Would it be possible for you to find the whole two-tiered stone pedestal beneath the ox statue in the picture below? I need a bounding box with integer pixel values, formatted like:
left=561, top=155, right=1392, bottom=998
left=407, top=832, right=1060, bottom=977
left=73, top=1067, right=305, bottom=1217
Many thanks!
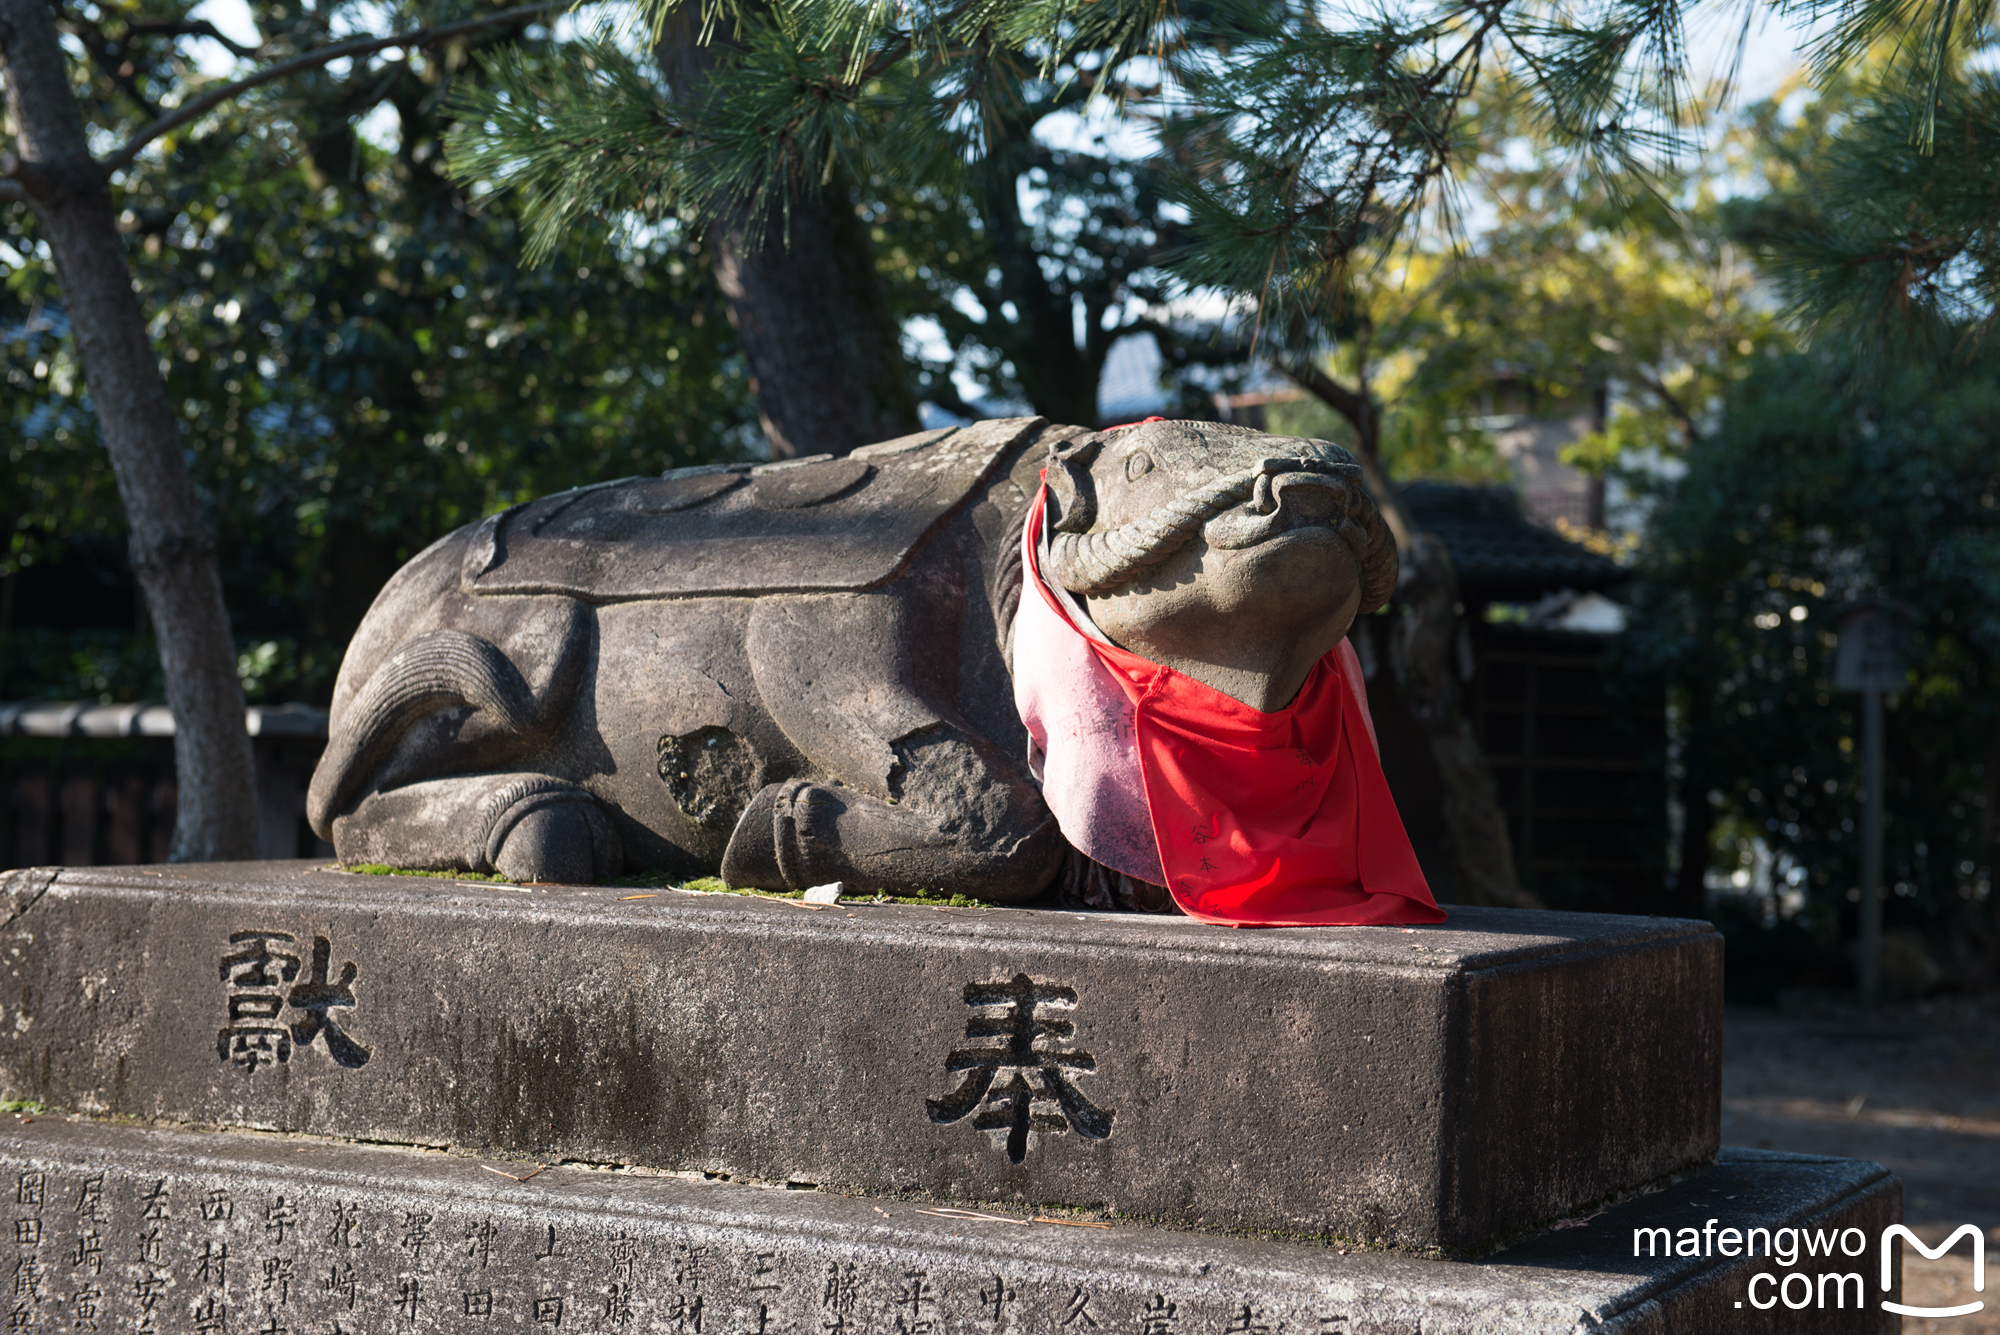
left=0, top=863, right=1902, bottom=1335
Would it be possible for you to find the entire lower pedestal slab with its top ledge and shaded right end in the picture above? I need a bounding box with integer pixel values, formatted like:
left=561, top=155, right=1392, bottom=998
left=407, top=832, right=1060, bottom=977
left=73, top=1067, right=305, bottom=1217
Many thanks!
left=0, top=1117, right=1900, bottom=1335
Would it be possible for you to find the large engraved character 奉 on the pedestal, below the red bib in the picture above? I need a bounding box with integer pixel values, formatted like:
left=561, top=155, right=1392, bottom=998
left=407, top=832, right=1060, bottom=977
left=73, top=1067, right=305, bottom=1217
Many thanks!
left=924, top=973, right=1116, bottom=1163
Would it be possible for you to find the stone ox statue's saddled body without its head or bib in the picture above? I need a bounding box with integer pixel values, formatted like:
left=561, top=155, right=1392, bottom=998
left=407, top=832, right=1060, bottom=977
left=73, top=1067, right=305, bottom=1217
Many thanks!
left=308, top=418, right=1080, bottom=901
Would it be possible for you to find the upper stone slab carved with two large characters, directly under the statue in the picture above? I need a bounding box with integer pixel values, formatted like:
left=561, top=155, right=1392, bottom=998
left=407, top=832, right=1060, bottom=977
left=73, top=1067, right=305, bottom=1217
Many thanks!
left=0, top=863, right=1722, bottom=1253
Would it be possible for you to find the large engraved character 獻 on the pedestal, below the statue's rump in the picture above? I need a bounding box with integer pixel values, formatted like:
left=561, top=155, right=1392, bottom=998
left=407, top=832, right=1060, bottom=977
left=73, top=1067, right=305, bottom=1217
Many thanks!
left=216, top=931, right=368, bottom=1071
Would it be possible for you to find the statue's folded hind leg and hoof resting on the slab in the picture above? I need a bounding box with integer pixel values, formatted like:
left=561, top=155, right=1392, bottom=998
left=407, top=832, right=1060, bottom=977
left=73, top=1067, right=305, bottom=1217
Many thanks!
left=334, top=773, right=624, bottom=881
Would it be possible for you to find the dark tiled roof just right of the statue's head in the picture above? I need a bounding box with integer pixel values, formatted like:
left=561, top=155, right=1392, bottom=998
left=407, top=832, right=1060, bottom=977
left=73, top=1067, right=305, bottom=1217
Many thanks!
left=1402, top=482, right=1630, bottom=602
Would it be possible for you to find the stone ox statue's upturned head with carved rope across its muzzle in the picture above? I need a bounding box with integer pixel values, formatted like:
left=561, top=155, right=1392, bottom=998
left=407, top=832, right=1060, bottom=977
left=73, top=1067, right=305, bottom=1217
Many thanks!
left=1042, top=422, right=1396, bottom=703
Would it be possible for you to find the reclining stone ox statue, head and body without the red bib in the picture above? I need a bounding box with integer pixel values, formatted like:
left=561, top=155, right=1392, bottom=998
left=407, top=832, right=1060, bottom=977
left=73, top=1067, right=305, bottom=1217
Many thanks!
left=306, top=418, right=1396, bottom=903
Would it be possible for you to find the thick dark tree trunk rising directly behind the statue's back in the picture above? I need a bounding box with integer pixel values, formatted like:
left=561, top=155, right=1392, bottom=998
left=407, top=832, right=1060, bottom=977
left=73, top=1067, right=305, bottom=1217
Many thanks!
left=658, top=6, right=918, bottom=458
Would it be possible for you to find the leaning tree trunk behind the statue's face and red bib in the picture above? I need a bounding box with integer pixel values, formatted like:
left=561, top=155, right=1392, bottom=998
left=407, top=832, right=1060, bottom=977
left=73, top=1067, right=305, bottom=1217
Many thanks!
left=1284, top=362, right=1542, bottom=907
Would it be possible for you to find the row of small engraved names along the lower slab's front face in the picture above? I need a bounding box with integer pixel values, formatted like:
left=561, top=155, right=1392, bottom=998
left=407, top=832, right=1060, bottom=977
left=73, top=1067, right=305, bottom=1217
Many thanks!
left=0, top=1159, right=1366, bottom=1335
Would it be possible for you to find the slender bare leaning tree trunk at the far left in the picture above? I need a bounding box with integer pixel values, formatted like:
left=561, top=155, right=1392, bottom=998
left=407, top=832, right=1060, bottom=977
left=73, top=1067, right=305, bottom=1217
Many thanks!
left=0, top=0, right=256, bottom=861
